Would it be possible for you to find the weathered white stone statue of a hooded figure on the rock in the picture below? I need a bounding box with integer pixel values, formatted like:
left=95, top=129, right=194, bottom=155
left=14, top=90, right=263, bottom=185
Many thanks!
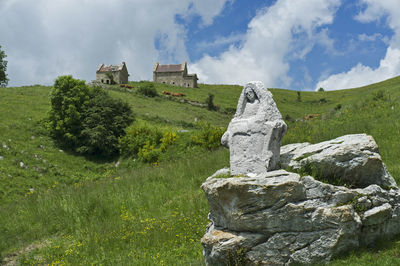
left=221, top=81, right=287, bottom=175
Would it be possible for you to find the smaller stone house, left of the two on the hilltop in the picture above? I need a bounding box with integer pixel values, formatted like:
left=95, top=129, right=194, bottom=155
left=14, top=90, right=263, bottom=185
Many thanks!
left=96, top=62, right=129, bottom=84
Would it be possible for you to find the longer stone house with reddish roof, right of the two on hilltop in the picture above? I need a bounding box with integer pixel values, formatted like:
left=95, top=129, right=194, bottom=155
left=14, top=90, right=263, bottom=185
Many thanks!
left=153, top=62, right=198, bottom=88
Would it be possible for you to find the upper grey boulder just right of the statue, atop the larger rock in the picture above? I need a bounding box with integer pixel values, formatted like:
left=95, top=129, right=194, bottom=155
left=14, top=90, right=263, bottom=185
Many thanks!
left=281, top=134, right=396, bottom=187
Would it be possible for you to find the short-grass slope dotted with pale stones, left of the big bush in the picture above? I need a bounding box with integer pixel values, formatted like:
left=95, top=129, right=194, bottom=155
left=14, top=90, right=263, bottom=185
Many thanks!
left=0, top=86, right=113, bottom=204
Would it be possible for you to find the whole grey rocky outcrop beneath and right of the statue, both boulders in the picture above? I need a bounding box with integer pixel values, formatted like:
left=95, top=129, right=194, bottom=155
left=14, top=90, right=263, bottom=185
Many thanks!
left=202, top=134, right=400, bottom=265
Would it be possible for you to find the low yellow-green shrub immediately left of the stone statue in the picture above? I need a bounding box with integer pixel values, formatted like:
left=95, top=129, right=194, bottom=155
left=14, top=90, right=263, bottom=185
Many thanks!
left=190, top=123, right=225, bottom=150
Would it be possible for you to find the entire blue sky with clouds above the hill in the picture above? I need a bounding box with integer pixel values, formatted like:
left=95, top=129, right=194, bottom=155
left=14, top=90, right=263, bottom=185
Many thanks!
left=0, top=0, right=400, bottom=90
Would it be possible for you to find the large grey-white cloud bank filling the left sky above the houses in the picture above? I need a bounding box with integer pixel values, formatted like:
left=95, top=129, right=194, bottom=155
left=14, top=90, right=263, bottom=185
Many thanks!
left=0, top=0, right=229, bottom=86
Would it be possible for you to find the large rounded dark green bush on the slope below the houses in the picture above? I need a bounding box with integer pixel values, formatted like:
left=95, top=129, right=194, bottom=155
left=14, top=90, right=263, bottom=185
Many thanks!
left=48, top=76, right=134, bottom=156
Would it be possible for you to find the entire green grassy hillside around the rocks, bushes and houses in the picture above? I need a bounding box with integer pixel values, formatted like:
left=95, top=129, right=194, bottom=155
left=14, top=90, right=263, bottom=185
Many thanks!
left=0, top=77, right=400, bottom=265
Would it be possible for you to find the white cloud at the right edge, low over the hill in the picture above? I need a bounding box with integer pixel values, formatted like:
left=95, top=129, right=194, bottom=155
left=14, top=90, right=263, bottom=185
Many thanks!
left=315, top=0, right=400, bottom=90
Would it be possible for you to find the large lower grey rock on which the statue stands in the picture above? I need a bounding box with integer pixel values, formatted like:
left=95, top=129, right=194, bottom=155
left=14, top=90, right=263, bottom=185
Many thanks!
left=202, top=170, right=400, bottom=265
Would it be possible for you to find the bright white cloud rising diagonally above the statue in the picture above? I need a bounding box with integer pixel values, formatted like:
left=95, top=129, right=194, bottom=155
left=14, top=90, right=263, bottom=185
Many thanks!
left=191, top=0, right=340, bottom=87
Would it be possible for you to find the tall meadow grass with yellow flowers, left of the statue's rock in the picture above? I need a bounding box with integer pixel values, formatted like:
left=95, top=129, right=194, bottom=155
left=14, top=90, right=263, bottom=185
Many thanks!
left=0, top=150, right=228, bottom=265
